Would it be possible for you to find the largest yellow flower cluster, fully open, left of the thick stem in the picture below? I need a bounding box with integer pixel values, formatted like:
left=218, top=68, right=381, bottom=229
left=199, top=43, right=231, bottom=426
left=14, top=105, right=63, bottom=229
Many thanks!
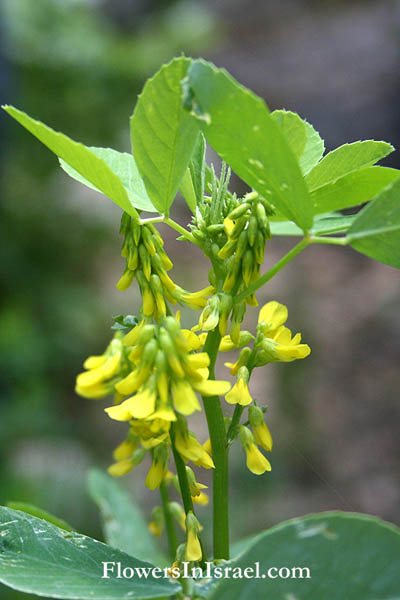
left=76, top=316, right=230, bottom=486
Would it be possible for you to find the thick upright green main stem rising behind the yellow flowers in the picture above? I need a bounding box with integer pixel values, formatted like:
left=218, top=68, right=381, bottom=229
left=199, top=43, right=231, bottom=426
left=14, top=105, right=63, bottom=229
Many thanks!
left=203, top=329, right=229, bottom=559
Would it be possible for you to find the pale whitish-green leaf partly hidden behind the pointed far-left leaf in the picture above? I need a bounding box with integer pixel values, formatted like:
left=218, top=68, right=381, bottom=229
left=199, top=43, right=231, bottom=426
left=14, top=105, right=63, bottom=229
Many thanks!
left=60, top=146, right=158, bottom=212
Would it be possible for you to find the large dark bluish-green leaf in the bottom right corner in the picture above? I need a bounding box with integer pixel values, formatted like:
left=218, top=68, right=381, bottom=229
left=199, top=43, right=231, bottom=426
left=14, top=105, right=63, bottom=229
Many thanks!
left=210, top=512, right=400, bottom=600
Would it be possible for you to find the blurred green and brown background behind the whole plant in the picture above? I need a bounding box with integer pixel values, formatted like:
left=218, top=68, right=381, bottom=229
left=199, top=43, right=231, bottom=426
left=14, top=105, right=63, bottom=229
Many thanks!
left=0, top=0, right=400, bottom=598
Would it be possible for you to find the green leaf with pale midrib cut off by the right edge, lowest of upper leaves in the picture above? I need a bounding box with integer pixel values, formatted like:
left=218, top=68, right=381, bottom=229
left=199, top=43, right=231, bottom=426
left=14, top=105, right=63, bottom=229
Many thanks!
left=348, top=179, right=400, bottom=269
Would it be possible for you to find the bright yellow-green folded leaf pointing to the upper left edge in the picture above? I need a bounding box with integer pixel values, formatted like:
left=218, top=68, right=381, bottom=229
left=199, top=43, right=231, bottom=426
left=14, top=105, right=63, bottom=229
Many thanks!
left=3, top=106, right=136, bottom=216
